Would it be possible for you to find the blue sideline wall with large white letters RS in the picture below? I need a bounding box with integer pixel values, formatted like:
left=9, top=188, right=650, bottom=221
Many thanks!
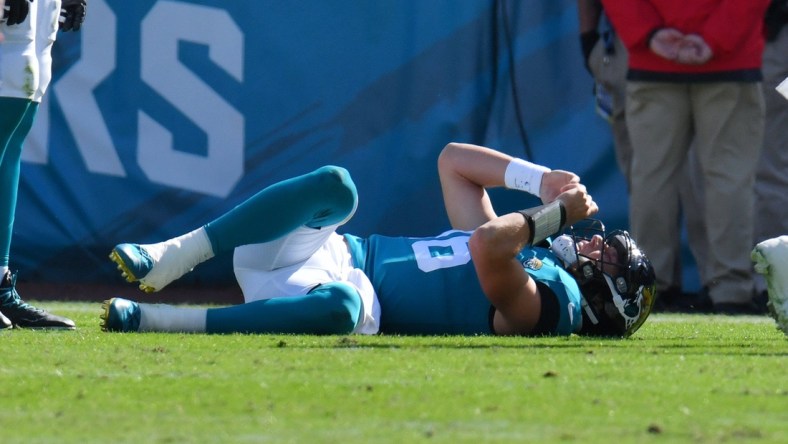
left=12, top=0, right=696, bottom=287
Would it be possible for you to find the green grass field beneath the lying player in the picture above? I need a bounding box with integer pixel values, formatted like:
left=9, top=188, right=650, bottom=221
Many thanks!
left=0, top=302, right=788, bottom=444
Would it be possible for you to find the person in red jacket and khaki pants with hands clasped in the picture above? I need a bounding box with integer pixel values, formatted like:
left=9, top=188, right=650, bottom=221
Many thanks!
left=602, top=0, right=769, bottom=314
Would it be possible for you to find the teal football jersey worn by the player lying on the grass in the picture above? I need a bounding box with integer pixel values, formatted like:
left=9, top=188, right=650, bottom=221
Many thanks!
left=345, top=230, right=581, bottom=335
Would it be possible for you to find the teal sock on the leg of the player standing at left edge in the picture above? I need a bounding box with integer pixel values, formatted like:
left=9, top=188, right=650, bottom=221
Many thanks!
left=0, top=97, right=38, bottom=267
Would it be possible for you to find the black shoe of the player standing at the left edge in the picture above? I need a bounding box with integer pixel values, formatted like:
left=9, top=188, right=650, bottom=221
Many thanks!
left=0, top=271, right=76, bottom=330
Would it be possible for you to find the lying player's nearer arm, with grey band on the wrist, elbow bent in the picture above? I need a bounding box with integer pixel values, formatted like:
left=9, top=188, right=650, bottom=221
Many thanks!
left=468, top=184, right=599, bottom=335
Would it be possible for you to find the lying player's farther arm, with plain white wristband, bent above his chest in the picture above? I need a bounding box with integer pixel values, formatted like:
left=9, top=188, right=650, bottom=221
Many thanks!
left=438, top=143, right=580, bottom=230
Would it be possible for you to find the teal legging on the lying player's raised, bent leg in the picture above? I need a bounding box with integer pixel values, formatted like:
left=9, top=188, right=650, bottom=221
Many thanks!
left=205, top=166, right=358, bottom=255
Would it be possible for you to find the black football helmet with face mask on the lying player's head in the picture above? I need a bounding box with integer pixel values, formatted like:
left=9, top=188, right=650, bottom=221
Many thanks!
left=568, top=219, right=656, bottom=337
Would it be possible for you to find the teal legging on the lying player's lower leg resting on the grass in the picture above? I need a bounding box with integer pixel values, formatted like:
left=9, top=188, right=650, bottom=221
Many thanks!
left=206, top=282, right=364, bottom=335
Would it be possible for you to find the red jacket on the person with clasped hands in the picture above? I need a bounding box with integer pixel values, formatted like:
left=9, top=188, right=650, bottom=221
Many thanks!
left=602, top=0, right=769, bottom=81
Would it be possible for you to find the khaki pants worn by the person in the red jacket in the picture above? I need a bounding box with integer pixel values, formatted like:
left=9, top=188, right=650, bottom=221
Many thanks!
left=626, top=82, right=764, bottom=303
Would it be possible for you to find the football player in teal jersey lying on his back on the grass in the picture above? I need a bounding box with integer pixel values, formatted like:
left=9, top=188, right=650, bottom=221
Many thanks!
left=101, top=143, right=655, bottom=337
